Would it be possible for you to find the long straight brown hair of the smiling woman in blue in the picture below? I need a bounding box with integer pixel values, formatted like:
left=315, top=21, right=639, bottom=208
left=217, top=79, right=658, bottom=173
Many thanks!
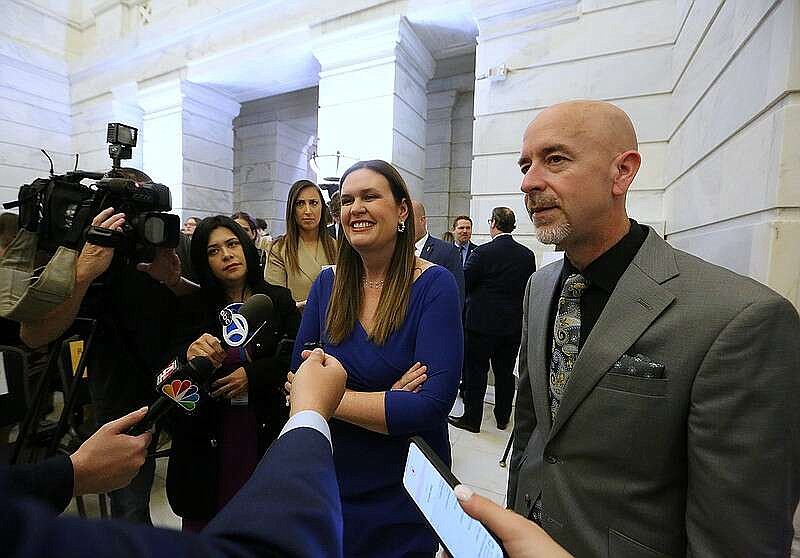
left=325, top=159, right=415, bottom=345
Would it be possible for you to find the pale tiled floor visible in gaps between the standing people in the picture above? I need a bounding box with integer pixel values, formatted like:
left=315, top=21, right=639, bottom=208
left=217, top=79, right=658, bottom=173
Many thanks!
left=67, top=400, right=512, bottom=529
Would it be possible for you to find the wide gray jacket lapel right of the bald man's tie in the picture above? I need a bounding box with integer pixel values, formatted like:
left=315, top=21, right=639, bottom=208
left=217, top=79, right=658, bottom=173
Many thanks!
left=545, top=230, right=678, bottom=439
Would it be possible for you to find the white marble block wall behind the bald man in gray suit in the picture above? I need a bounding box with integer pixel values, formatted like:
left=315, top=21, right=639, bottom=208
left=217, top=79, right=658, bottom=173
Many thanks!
left=472, top=0, right=800, bottom=305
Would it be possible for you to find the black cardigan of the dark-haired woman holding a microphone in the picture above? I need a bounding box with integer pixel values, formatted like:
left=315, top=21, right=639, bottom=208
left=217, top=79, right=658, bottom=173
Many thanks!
left=167, top=281, right=300, bottom=520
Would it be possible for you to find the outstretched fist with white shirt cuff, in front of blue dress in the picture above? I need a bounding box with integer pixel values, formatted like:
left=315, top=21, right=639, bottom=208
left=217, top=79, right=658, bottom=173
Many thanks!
left=285, top=349, right=347, bottom=420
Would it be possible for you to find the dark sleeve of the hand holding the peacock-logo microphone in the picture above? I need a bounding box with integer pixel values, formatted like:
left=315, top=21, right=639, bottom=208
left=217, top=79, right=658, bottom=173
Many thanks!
left=8, top=455, right=75, bottom=513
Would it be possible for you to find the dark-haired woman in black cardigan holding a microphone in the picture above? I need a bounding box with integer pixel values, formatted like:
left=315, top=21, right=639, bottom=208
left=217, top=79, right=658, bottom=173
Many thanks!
left=167, top=215, right=300, bottom=531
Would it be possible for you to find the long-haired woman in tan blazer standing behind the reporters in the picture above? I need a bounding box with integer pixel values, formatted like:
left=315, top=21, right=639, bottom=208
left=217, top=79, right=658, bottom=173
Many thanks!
left=266, top=180, right=336, bottom=308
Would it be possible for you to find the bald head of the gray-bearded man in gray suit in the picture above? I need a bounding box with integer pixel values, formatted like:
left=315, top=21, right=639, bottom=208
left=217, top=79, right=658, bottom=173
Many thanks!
left=519, top=101, right=641, bottom=265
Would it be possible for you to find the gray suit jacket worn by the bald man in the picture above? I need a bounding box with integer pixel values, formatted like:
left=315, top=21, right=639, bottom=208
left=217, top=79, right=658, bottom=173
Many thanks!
left=508, top=230, right=800, bottom=557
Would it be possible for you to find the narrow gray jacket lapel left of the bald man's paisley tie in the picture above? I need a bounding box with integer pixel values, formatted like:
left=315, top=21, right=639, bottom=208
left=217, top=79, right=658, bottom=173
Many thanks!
left=528, top=263, right=564, bottom=432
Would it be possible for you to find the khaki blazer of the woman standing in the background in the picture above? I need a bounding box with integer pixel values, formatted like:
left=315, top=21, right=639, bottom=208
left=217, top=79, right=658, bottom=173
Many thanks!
left=264, top=237, right=336, bottom=302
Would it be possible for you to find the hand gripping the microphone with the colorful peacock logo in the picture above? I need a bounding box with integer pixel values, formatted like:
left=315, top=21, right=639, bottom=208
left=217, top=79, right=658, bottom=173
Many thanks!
left=69, top=407, right=152, bottom=496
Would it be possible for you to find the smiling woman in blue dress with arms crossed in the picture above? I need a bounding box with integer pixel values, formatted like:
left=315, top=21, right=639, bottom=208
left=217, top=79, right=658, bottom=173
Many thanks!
left=287, top=160, right=463, bottom=557
